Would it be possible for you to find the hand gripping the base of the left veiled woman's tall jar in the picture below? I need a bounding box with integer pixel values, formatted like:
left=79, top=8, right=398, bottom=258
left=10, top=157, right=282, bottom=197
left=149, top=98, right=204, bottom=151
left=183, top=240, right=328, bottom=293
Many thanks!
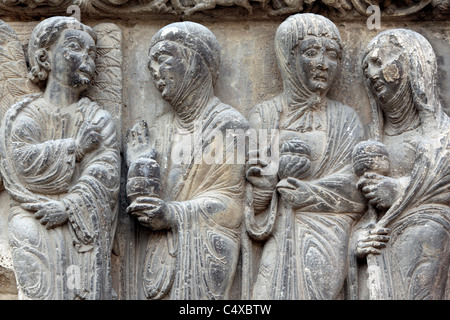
left=127, top=197, right=172, bottom=230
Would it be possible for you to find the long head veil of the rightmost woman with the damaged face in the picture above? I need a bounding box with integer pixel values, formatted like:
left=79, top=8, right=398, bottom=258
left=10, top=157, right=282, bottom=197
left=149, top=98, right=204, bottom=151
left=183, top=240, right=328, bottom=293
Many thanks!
left=363, top=29, right=448, bottom=138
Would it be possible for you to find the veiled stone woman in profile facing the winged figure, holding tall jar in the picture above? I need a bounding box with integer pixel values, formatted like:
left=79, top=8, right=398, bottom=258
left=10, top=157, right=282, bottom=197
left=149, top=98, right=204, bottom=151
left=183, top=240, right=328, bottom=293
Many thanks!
left=127, top=22, right=248, bottom=300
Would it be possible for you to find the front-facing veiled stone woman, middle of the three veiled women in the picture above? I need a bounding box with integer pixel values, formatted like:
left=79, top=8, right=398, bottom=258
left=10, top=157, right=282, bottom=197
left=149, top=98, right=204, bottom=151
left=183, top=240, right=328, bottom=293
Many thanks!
left=244, top=14, right=365, bottom=299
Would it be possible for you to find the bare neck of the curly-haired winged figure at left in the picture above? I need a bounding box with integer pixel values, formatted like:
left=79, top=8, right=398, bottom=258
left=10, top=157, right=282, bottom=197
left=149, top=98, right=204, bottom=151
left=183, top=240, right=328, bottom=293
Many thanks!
left=44, top=74, right=81, bottom=107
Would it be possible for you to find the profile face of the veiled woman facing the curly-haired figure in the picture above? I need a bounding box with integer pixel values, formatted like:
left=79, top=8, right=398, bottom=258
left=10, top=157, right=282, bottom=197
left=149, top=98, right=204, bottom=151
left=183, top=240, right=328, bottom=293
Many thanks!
left=148, top=41, right=189, bottom=103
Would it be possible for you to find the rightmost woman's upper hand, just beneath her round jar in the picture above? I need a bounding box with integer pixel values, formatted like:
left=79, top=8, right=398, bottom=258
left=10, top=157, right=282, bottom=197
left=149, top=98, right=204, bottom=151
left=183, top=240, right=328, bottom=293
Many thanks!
left=357, top=172, right=403, bottom=210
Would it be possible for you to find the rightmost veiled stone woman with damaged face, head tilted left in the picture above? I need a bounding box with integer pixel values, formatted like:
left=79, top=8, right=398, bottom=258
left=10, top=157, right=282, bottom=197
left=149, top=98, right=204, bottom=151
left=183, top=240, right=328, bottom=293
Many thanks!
left=350, top=29, right=450, bottom=300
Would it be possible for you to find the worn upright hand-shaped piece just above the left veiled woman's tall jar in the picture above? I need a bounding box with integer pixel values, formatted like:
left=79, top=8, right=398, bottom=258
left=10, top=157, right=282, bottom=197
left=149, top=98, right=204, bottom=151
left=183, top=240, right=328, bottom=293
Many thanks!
left=125, top=120, right=156, bottom=167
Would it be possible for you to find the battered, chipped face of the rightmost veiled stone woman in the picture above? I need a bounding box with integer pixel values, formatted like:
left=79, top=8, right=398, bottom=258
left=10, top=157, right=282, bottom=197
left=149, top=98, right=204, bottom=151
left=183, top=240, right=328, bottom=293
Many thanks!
left=363, top=37, right=407, bottom=104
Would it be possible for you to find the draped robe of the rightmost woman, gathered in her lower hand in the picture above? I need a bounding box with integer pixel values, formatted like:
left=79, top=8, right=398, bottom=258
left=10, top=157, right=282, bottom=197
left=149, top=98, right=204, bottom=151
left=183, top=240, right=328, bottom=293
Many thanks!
left=348, top=117, right=450, bottom=300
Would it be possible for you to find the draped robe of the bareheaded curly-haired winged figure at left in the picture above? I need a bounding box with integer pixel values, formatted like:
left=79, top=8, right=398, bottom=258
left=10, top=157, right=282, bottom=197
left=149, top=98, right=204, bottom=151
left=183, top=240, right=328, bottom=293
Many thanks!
left=0, top=94, right=120, bottom=300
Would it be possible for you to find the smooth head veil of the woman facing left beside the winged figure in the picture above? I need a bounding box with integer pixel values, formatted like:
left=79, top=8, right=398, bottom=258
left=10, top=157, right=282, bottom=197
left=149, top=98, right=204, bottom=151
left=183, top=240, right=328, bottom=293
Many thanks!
left=150, top=22, right=220, bottom=128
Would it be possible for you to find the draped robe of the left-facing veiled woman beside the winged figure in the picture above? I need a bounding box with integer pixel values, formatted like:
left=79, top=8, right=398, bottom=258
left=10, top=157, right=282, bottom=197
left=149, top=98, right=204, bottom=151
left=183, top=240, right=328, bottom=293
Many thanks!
left=137, top=97, right=248, bottom=300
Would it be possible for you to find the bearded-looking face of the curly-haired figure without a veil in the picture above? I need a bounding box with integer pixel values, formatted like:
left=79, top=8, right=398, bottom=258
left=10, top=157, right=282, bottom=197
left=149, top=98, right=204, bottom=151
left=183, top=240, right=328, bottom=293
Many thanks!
left=49, top=29, right=96, bottom=89
